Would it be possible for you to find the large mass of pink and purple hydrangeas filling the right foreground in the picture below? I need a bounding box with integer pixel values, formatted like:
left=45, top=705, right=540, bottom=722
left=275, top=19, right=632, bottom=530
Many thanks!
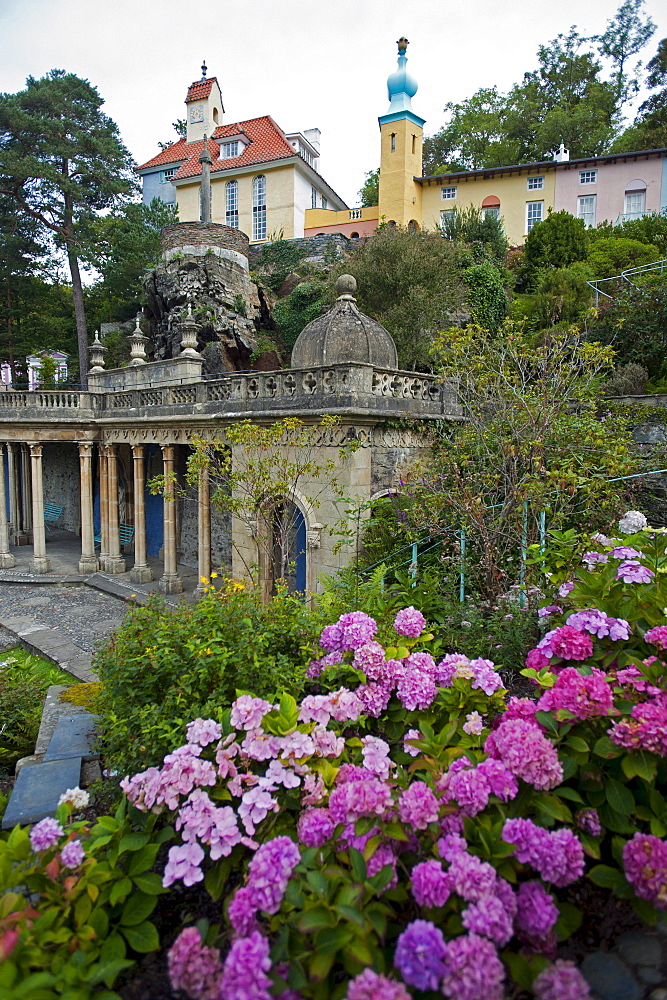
left=109, top=512, right=667, bottom=1000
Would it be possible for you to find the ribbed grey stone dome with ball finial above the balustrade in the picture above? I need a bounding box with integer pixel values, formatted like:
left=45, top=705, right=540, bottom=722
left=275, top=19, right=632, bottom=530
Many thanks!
left=292, top=274, right=398, bottom=369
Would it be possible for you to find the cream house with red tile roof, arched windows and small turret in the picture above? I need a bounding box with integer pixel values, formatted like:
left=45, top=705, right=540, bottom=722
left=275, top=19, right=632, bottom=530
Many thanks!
left=138, top=66, right=347, bottom=243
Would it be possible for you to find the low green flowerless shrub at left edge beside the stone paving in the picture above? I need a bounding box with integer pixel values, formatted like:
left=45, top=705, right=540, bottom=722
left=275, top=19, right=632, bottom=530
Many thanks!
left=0, top=648, right=72, bottom=774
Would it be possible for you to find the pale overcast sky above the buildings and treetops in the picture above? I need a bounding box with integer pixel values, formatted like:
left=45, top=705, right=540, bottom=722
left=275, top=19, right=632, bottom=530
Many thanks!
left=0, top=0, right=667, bottom=205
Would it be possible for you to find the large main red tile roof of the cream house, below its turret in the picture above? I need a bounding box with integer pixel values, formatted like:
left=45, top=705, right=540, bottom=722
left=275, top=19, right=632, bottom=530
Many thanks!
left=138, top=115, right=297, bottom=180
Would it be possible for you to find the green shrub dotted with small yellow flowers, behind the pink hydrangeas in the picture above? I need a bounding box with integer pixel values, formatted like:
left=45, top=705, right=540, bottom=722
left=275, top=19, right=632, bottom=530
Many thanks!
left=95, top=581, right=317, bottom=773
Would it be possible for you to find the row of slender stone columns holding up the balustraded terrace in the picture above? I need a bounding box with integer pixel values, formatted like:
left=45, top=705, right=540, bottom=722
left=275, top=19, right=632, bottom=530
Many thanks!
left=0, top=441, right=211, bottom=594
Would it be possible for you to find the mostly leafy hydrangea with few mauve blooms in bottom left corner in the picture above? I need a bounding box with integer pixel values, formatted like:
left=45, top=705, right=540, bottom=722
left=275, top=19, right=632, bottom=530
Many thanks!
left=0, top=788, right=173, bottom=1000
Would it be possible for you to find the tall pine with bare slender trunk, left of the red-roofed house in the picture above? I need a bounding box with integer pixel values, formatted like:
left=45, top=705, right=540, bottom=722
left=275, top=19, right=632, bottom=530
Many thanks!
left=0, top=70, right=135, bottom=386
